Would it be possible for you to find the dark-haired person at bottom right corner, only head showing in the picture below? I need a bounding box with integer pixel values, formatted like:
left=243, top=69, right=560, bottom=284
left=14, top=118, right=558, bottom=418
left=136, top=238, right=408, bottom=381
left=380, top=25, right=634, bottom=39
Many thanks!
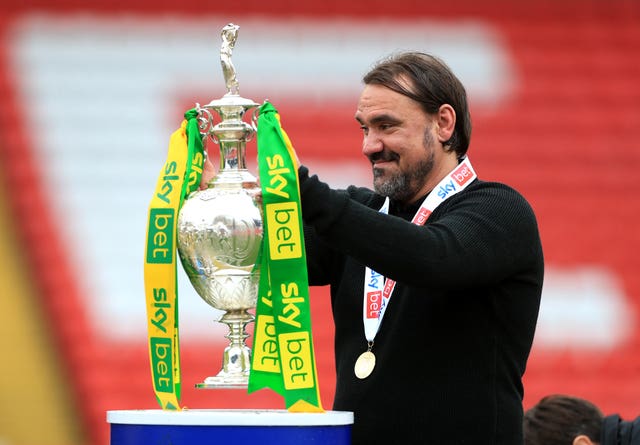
left=524, top=394, right=640, bottom=445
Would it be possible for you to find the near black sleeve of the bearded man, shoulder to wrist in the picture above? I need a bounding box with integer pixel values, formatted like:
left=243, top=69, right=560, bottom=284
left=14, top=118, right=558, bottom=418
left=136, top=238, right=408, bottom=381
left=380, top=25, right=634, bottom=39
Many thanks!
left=300, top=167, right=541, bottom=289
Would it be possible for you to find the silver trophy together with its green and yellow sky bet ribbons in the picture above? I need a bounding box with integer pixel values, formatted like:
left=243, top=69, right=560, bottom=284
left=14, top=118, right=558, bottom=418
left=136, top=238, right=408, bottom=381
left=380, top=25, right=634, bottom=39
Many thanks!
left=145, top=24, right=323, bottom=412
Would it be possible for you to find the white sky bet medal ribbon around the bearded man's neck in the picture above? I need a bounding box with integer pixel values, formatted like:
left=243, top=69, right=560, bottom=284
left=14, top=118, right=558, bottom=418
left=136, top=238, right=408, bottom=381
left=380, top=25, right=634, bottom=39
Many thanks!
left=362, top=158, right=477, bottom=344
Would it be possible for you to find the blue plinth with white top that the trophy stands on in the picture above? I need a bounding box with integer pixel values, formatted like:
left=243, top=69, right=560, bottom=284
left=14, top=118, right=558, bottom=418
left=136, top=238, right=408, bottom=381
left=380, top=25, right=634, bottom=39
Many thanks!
left=107, top=409, right=353, bottom=445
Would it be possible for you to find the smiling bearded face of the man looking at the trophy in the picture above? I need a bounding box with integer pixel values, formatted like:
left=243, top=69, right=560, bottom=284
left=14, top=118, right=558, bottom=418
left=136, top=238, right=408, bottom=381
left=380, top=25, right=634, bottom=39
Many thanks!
left=355, top=85, right=441, bottom=203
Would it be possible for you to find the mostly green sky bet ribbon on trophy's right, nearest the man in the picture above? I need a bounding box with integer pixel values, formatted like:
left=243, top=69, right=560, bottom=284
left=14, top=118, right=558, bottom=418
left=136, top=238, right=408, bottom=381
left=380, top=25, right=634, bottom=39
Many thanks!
left=249, top=102, right=324, bottom=412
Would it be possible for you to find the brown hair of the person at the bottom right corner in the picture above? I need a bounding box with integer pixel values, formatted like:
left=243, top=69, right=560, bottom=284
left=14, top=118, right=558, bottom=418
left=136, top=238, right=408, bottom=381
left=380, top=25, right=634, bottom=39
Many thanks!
left=523, top=395, right=604, bottom=445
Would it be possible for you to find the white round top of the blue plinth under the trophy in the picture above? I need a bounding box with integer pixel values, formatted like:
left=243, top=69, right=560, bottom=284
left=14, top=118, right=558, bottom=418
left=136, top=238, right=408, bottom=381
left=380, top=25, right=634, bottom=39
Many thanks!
left=107, top=409, right=353, bottom=426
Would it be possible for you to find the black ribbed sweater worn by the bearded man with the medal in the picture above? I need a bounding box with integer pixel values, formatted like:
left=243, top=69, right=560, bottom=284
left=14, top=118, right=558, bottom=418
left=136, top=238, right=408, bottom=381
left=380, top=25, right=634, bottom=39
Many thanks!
left=299, top=167, right=543, bottom=445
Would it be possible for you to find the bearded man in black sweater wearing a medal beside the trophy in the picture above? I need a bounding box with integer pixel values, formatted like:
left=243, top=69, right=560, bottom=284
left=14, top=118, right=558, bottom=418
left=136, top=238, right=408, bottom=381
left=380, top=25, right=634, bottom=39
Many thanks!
left=299, top=52, right=543, bottom=445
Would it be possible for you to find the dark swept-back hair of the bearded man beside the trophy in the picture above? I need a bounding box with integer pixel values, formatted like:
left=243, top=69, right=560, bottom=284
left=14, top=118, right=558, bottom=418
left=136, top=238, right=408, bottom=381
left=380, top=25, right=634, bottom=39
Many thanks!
left=362, top=52, right=471, bottom=158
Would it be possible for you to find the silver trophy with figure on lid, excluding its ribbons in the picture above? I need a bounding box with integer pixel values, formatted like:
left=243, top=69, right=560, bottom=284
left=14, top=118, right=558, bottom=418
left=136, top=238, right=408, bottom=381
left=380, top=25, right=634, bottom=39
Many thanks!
left=177, top=24, right=262, bottom=388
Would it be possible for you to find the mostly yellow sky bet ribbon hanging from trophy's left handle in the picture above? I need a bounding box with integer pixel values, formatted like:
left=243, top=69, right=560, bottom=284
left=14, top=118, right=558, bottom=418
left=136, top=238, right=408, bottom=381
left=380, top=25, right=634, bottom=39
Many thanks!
left=144, top=109, right=204, bottom=410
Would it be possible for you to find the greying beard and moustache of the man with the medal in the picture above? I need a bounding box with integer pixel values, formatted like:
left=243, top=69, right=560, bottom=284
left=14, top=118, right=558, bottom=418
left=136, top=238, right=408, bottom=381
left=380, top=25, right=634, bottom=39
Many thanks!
left=370, top=130, right=435, bottom=202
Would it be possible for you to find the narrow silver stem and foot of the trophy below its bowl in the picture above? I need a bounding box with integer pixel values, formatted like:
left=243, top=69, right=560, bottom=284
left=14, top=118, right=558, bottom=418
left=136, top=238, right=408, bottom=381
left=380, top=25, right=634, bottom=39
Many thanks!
left=196, top=309, right=254, bottom=389
